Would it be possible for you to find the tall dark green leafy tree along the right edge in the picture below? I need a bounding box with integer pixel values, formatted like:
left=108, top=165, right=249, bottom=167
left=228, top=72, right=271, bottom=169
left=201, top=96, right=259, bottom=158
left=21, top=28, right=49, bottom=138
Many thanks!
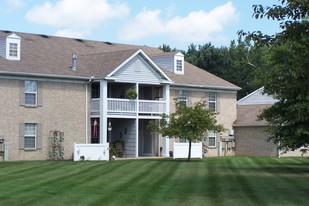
left=239, top=0, right=309, bottom=150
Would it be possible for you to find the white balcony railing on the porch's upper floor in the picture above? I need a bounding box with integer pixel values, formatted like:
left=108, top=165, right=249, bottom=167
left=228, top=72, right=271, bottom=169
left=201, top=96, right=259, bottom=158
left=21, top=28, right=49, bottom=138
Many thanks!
left=91, top=98, right=166, bottom=116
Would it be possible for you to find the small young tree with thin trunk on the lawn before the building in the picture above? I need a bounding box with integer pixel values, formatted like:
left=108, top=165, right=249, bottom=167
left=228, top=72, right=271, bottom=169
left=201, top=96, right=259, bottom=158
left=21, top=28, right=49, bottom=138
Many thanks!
left=149, top=100, right=224, bottom=161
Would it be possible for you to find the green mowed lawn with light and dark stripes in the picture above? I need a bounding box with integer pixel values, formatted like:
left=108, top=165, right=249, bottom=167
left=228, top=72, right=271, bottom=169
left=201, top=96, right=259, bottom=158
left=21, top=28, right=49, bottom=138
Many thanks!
left=0, top=157, right=309, bottom=206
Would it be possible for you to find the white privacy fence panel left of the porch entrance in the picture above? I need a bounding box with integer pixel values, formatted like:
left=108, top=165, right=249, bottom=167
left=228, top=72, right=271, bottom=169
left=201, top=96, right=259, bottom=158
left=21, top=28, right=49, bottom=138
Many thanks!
left=73, top=143, right=109, bottom=161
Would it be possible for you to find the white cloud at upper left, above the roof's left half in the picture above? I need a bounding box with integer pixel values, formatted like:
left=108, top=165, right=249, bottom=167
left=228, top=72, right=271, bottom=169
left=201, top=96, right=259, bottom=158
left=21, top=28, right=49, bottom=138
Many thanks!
left=26, top=0, right=129, bottom=37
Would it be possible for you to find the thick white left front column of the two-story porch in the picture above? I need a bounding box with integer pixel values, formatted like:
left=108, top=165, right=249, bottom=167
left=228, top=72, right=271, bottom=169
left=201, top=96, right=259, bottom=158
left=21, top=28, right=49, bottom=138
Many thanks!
left=100, top=80, right=107, bottom=143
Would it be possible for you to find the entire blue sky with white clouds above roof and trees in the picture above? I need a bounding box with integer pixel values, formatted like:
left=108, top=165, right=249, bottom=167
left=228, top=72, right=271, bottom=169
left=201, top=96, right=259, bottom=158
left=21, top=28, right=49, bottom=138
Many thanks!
left=0, top=0, right=280, bottom=50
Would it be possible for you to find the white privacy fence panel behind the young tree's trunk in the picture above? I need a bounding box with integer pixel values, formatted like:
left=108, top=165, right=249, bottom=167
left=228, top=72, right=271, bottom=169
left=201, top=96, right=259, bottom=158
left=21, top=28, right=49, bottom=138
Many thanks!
left=173, top=142, right=203, bottom=159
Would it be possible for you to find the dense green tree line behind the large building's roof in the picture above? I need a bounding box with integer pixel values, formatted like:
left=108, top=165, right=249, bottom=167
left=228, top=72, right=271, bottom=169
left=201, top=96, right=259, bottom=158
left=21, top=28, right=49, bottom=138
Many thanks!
left=159, top=38, right=267, bottom=99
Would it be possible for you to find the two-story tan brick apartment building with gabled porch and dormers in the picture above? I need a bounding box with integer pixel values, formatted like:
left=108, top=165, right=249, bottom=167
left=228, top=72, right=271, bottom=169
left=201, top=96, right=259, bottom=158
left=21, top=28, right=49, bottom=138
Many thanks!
left=0, top=31, right=240, bottom=160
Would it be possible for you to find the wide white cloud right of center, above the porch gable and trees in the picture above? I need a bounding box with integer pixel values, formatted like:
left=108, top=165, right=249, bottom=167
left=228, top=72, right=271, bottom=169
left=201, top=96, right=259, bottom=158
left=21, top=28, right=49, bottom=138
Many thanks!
left=120, top=2, right=238, bottom=43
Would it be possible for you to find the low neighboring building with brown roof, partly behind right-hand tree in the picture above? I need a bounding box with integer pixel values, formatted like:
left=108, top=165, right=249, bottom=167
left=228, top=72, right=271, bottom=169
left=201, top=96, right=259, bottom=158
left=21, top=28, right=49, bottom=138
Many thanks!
left=233, top=87, right=301, bottom=157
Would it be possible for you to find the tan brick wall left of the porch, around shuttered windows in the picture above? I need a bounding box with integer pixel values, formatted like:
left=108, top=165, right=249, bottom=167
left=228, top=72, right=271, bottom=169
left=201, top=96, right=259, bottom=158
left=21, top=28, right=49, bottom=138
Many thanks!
left=0, top=79, right=86, bottom=161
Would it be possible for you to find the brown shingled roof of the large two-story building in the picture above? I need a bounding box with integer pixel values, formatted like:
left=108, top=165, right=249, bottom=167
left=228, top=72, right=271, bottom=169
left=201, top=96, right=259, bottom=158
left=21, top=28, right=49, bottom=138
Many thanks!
left=0, top=31, right=240, bottom=90
